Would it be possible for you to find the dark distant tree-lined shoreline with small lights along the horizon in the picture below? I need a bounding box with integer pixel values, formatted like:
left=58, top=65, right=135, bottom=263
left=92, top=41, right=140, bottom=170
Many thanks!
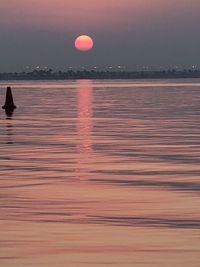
left=0, top=69, right=200, bottom=81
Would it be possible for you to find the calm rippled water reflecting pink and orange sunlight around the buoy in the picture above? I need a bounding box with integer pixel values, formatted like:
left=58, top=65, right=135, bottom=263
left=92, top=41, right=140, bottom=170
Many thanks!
left=0, top=80, right=200, bottom=267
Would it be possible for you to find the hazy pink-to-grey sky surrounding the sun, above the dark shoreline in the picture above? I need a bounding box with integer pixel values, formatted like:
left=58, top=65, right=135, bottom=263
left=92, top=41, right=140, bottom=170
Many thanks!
left=0, top=0, right=200, bottom=71
